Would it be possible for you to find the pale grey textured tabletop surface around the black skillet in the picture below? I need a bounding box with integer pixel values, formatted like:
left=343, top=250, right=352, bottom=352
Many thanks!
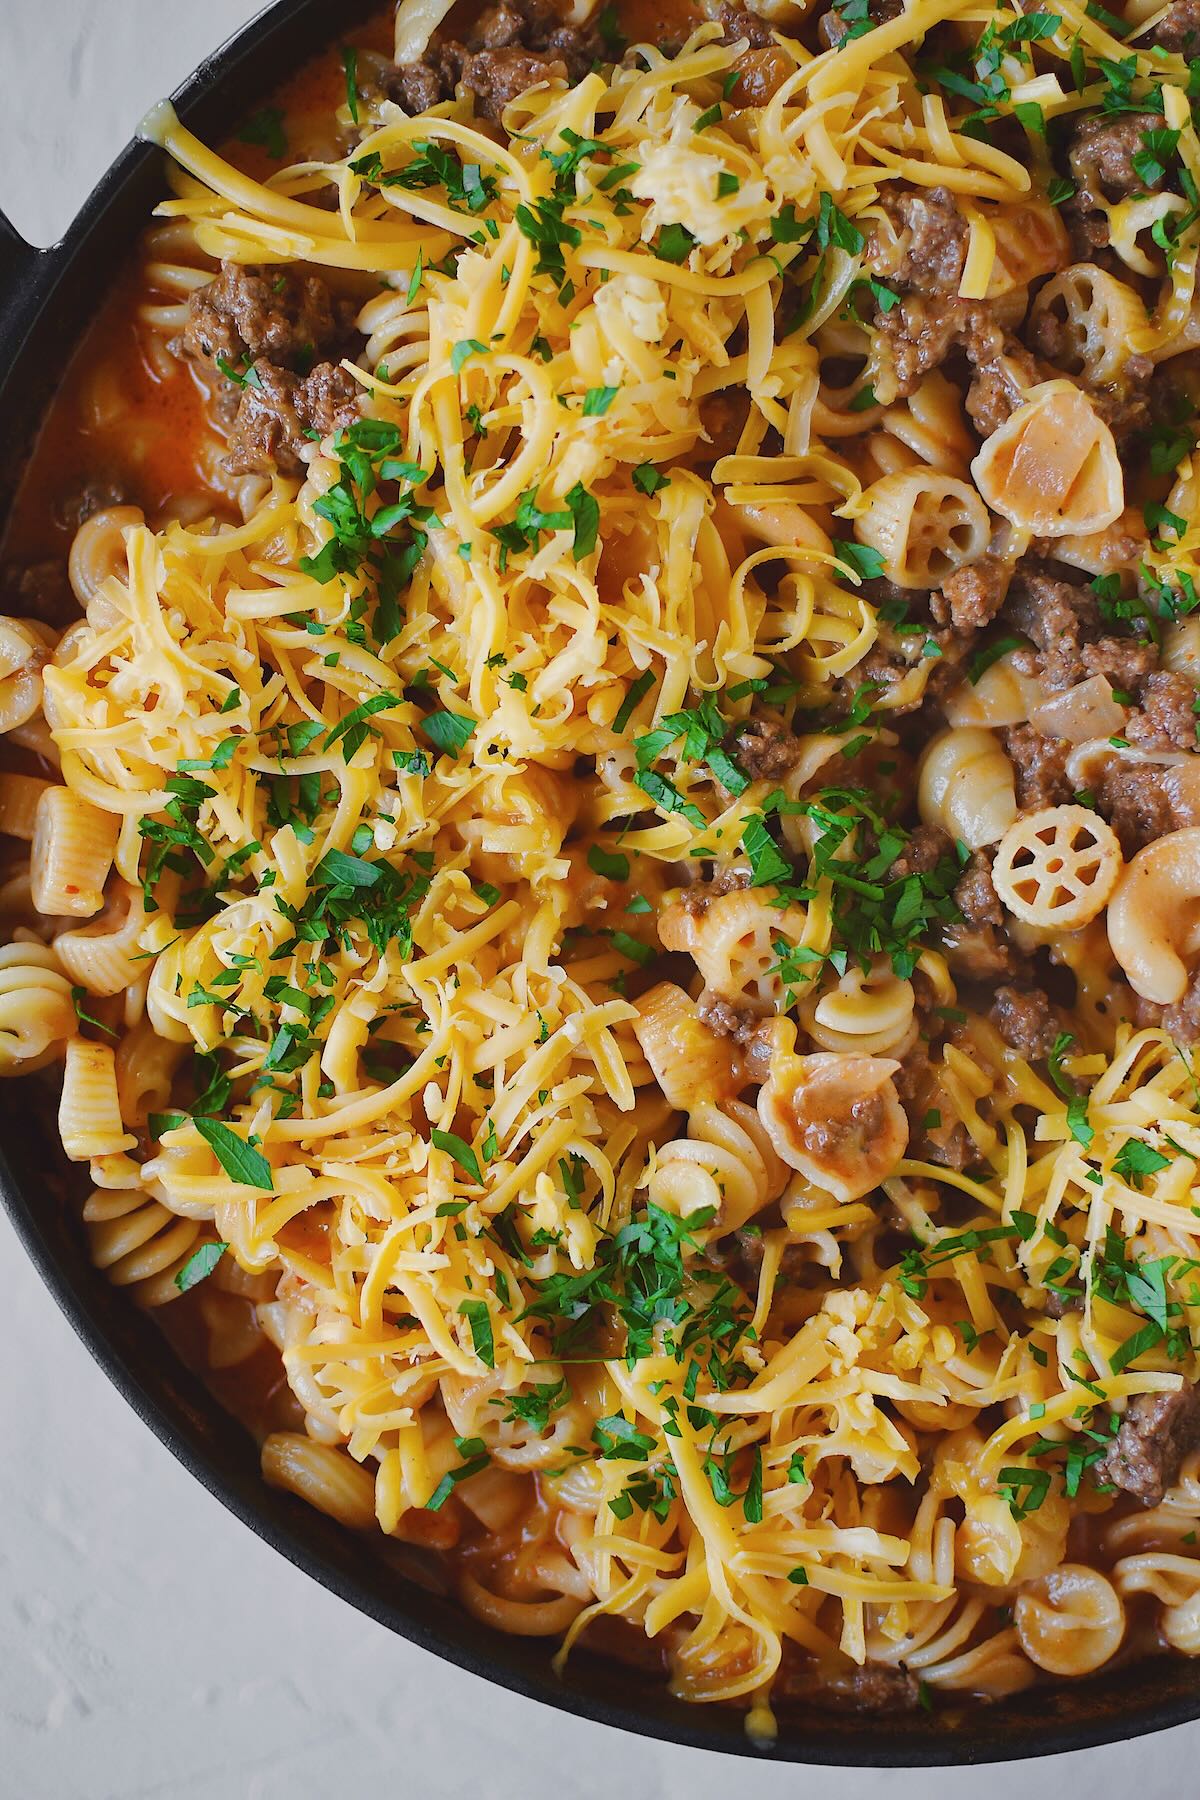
left=0, top=0, right=1200, bottom=1800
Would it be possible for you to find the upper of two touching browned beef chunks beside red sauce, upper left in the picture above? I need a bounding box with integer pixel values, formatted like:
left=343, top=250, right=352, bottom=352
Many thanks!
left=184, top=263, right=345, bottom=374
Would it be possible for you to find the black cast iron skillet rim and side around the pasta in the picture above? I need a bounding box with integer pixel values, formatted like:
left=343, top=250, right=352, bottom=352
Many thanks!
left=0, top=0, right=1200, bottom=1768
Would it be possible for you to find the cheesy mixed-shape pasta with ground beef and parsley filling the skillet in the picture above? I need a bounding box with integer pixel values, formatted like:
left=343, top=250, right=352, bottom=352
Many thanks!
left=9, top=0, right=1200, bottom=1735
